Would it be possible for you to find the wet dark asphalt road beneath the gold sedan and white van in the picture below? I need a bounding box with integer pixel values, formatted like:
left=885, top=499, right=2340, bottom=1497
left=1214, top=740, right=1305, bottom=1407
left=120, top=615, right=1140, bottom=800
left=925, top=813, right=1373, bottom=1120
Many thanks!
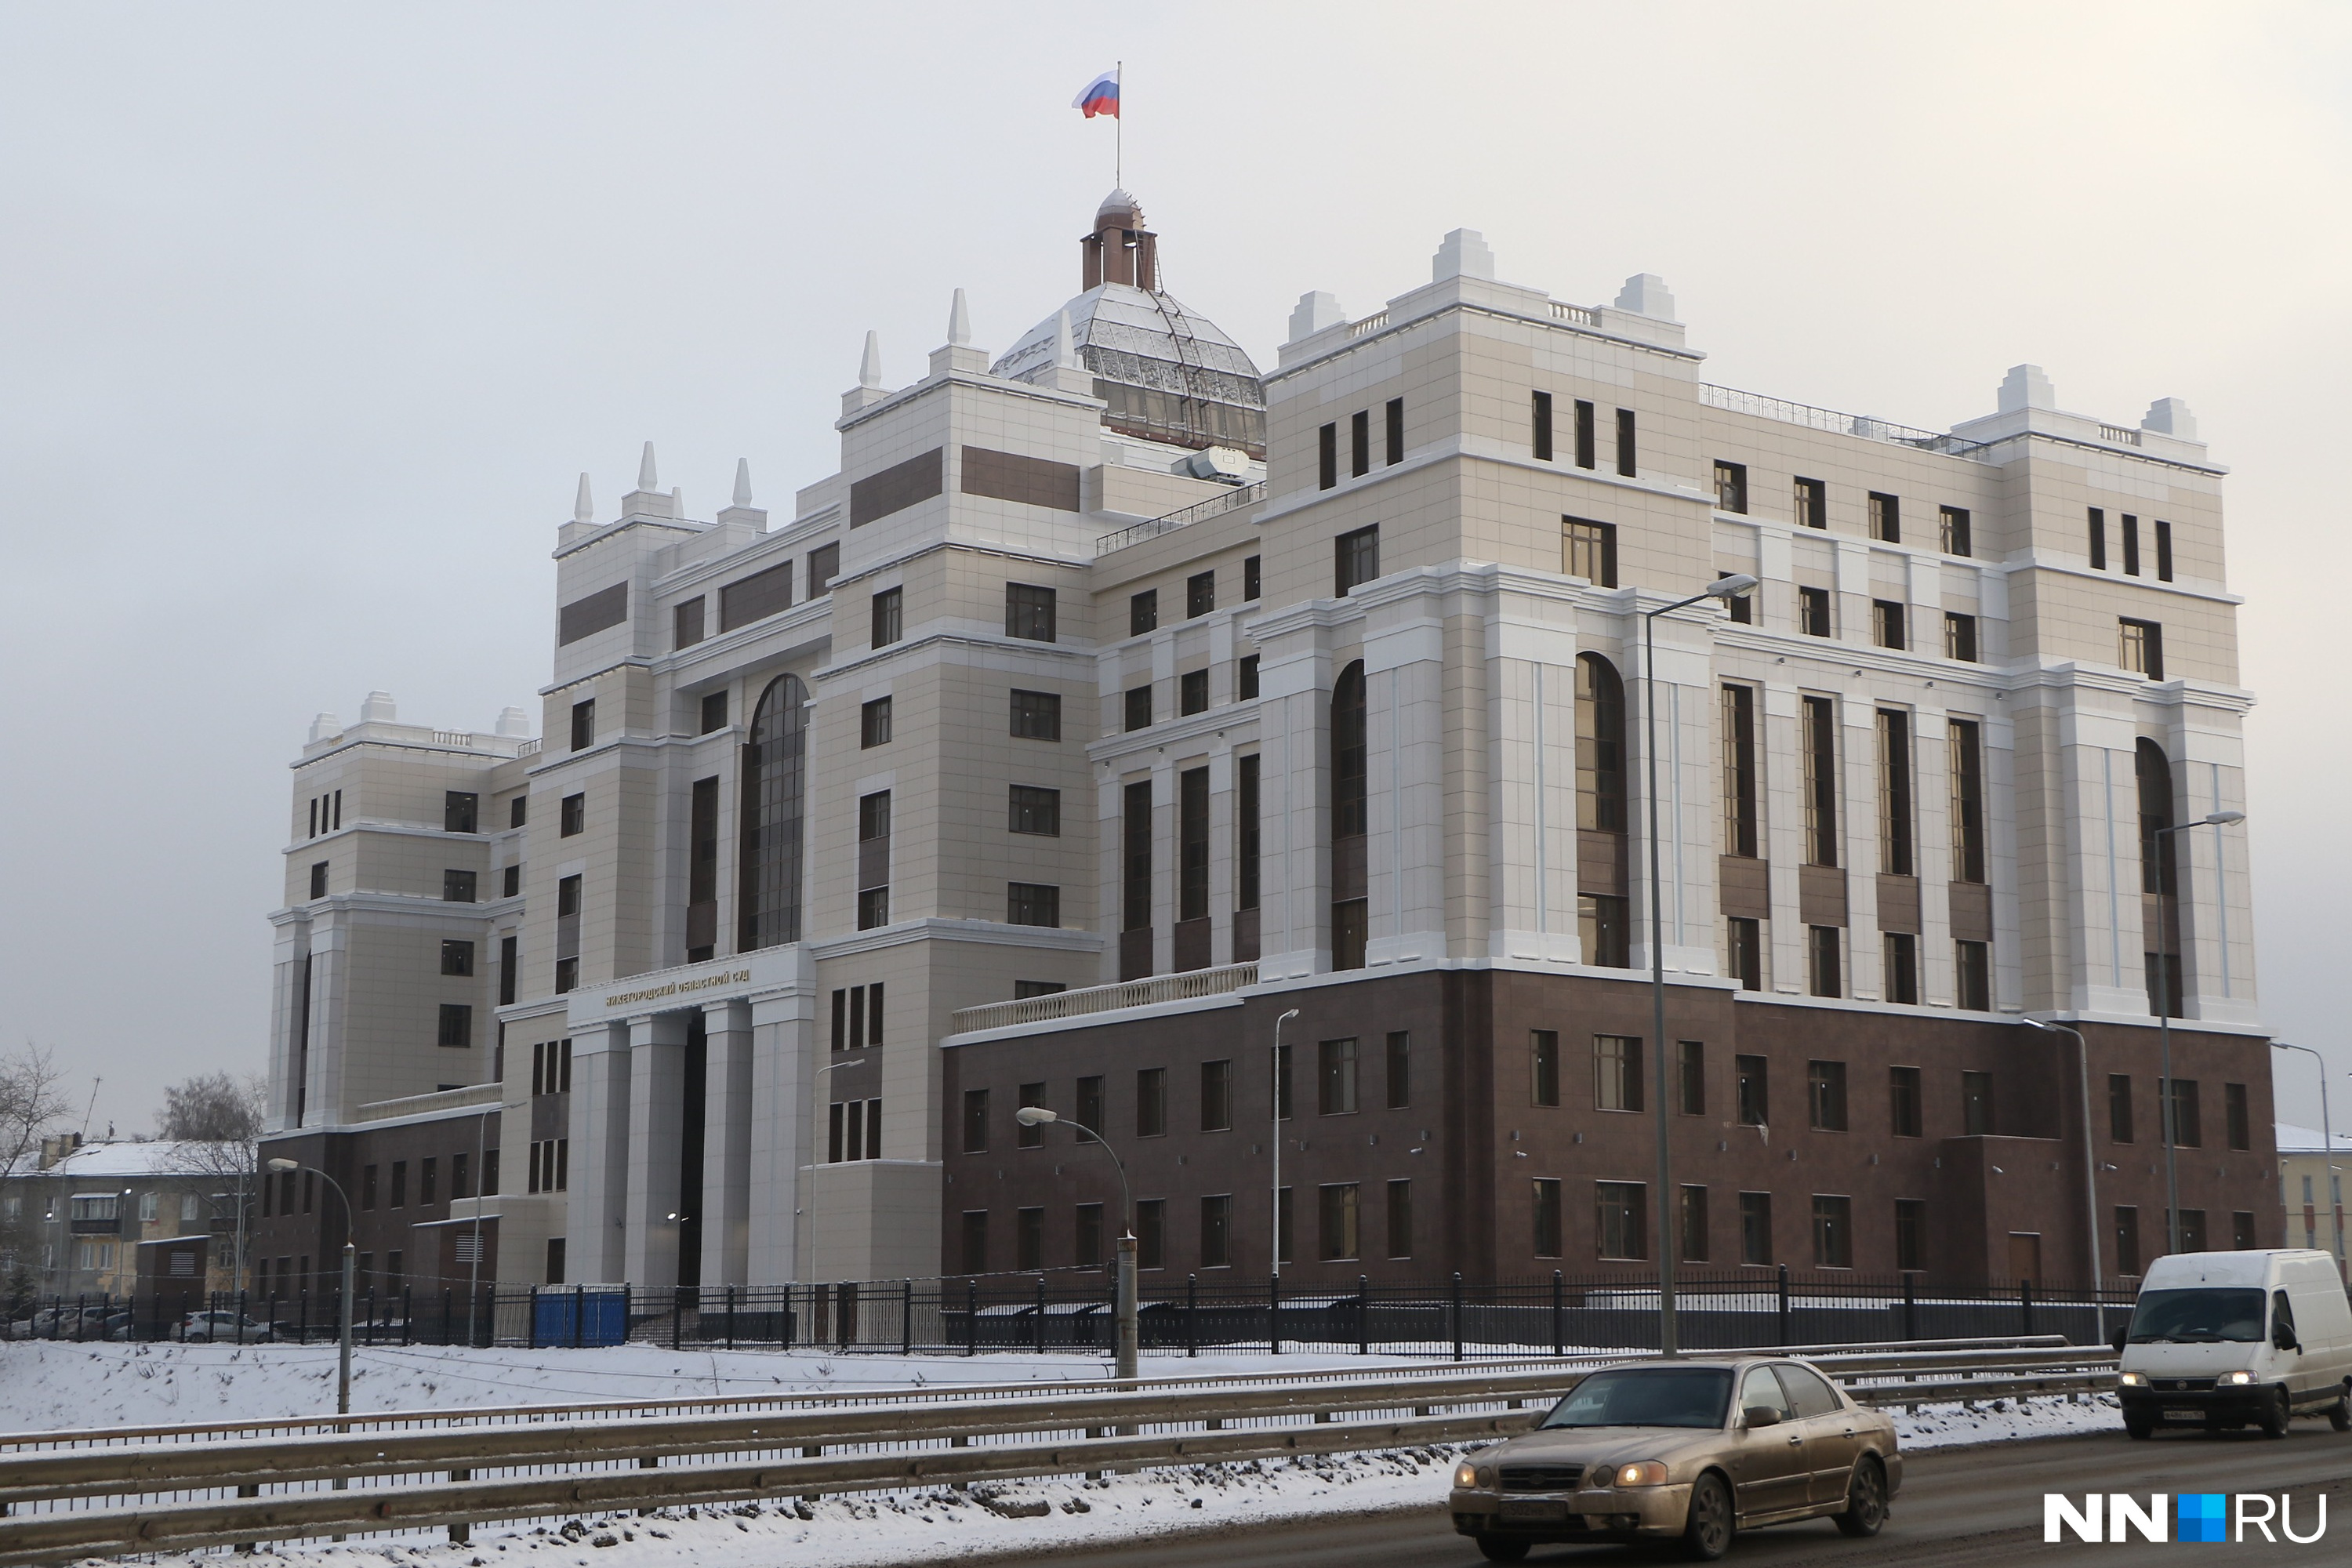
left=1002, top=1420, right=2352, bottom=1568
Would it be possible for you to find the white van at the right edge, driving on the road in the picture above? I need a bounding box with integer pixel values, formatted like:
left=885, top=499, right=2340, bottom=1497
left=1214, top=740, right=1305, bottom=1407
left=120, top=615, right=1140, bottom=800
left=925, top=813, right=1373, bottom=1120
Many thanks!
left=2117, top=1248, right=2352, bottom=1436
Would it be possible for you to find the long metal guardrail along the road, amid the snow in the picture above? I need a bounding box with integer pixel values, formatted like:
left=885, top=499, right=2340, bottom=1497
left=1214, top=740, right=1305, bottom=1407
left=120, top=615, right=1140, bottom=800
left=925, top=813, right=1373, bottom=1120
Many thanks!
left=0, top=1342, right=2114, bottom=1568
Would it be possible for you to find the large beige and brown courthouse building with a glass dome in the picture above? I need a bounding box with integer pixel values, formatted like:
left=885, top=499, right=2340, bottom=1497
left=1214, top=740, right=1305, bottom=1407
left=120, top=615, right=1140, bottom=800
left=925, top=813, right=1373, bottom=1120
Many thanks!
left=259, top=193, right=2279, bottom=1288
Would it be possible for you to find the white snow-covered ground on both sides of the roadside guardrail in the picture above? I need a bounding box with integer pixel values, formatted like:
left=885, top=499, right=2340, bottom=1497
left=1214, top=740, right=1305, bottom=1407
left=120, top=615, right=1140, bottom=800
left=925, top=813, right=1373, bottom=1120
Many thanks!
left=0, top=1345, right=2119, bottom=1568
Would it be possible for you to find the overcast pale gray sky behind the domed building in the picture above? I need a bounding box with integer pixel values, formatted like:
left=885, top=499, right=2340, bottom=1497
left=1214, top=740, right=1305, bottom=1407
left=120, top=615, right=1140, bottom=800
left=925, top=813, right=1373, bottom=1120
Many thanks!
left=0, top=0, right=2352, bottom=1133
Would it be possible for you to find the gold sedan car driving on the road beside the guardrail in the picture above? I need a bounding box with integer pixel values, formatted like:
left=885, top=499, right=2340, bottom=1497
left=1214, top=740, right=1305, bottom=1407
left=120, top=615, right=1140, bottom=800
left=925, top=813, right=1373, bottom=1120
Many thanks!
left=1449, top=1356, right=1903, bottom=1563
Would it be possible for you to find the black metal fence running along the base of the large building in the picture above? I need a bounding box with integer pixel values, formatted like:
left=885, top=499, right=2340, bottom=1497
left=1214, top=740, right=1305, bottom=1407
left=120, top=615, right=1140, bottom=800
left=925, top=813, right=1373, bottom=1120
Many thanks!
left=9, top=1267, right=2133, bottom=1361
